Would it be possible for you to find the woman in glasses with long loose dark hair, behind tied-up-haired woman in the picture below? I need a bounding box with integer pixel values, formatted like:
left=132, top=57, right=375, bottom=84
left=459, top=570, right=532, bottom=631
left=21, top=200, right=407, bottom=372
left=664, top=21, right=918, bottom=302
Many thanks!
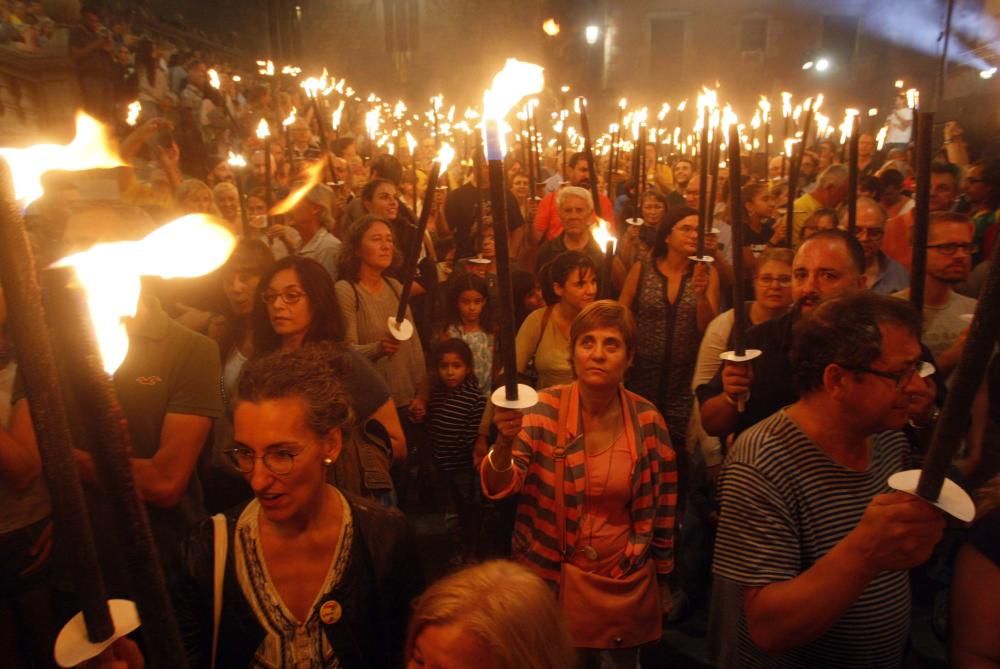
left=253, top=256, right=406, bottom=505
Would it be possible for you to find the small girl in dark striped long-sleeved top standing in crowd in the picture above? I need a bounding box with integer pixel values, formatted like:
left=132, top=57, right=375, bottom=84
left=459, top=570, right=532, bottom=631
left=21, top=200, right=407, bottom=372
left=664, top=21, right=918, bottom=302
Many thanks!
left=427, top=338, right=486, bottom=562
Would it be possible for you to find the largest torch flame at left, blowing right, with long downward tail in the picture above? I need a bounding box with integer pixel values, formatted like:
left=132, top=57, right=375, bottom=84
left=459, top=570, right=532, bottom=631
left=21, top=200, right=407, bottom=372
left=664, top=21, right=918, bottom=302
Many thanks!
left=56, top=214, right=236, bottom=374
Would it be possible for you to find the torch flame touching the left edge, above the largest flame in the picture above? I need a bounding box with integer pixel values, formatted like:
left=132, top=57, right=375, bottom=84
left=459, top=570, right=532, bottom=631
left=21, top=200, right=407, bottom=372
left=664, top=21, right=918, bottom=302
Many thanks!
left=0, top=112, right=125, bottom=206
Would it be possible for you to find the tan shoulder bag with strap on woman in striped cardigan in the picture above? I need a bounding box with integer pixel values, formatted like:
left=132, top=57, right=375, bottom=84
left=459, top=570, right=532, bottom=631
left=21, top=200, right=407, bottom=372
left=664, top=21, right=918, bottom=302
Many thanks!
left=552, top=388, right=662, bottom=649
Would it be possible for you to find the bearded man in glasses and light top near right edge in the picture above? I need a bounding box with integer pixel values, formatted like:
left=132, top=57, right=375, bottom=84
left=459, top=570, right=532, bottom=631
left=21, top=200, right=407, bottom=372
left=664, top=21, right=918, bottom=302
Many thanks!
left=895, top=211, right=976, bottom=376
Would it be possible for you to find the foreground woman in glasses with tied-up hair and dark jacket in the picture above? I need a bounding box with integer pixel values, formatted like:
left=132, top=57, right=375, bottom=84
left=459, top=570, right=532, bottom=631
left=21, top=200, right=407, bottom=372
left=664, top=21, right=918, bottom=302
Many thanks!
left=174, top=344, right=422, bottom=669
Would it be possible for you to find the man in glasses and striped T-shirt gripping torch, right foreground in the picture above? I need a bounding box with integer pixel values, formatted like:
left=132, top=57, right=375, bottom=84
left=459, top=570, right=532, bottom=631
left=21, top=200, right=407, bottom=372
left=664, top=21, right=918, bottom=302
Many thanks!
left=710, top=291, right=945, bottom=667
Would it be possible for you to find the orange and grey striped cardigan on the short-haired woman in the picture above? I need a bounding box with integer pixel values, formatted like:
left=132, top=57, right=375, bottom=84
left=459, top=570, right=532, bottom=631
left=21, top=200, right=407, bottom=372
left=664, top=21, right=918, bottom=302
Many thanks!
left=480, top=383, right=677, bottom=589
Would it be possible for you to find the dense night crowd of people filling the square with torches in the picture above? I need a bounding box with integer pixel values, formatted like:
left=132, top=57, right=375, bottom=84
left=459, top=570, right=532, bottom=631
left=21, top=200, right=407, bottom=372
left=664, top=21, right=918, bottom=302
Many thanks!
left=0, top=2, right=1000, bottom=669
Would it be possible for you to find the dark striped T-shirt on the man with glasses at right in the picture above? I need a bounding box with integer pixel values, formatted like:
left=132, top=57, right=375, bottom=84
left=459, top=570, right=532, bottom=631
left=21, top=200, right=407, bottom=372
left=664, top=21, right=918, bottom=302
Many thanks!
left=713, top=410, right=910, bottom=669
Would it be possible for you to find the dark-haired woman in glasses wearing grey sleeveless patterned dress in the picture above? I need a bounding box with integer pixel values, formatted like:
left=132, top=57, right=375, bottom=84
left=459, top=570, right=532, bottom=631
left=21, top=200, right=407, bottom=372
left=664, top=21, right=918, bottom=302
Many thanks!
left=619, top=207, right=719, bottom=454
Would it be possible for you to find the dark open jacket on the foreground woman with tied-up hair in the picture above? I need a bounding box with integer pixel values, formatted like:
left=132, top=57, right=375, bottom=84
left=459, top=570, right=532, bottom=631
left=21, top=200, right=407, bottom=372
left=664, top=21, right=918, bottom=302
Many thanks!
left=174, top=493, right=423, bottom=669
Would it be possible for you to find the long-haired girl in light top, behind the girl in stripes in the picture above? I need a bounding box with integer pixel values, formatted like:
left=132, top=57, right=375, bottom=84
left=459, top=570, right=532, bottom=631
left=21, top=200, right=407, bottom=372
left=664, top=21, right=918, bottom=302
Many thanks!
left=441, top=274, right=496, bottom=397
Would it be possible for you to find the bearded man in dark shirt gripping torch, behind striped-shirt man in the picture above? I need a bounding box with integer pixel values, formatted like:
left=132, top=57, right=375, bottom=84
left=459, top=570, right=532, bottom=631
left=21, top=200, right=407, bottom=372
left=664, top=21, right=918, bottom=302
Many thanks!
left=697, top=230, right=865, bottom=437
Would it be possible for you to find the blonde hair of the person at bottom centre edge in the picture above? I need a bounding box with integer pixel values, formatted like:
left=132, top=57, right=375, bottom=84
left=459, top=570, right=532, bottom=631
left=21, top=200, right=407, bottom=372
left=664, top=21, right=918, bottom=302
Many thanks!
left=404, top=560, right=575, bottom=669
